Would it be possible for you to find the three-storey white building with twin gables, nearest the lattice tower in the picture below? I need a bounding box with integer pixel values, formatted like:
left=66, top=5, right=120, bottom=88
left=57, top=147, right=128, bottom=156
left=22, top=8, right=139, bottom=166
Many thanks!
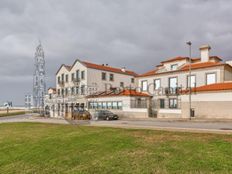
left=46, top=60, right=137, bottom=118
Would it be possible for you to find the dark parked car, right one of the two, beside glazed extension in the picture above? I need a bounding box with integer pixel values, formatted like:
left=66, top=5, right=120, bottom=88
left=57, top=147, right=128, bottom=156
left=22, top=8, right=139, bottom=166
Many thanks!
left=93, top=110, right=118, bottom=120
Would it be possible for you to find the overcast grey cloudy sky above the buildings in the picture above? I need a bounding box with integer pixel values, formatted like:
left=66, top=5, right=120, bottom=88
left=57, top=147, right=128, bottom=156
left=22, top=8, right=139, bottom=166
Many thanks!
left=0, top=0, right=232, bottom=105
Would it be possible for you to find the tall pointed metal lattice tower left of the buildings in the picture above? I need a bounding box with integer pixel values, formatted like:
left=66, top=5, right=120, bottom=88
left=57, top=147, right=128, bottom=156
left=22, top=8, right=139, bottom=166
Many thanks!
left=33, top=43, right=46, bottom=109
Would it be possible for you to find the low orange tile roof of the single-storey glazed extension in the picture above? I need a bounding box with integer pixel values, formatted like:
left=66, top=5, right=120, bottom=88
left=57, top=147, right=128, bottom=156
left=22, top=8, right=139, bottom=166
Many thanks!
left=87, top=89, right=150, bottom=98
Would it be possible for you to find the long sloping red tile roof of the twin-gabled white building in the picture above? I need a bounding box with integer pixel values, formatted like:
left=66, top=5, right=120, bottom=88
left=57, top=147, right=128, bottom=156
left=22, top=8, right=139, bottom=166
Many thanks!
left=81, top=61, right=138, bottom=76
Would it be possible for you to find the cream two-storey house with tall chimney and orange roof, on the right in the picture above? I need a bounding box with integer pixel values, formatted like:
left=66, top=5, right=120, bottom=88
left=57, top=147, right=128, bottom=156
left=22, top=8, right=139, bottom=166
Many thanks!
left=137, top=45, right=232, bottom=118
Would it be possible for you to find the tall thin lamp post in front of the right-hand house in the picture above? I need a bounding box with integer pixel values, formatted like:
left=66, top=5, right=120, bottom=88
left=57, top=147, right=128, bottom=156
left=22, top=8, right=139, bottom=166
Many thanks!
left=186, top=41, right=192, bottom=120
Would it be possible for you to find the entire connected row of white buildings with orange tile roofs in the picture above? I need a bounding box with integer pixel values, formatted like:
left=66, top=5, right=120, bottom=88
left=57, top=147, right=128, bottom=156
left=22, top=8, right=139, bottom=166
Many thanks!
left=46, top=45, right=232, bottom=118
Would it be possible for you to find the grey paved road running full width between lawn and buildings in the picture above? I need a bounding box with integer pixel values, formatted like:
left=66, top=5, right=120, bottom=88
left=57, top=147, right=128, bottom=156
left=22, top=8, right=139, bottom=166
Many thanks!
left=0, top=114, right=232, bottom=134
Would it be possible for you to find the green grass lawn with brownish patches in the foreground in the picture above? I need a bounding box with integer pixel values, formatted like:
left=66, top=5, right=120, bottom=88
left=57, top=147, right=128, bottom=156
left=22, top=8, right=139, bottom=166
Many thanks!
left=0, top=123, right=232, bottom=174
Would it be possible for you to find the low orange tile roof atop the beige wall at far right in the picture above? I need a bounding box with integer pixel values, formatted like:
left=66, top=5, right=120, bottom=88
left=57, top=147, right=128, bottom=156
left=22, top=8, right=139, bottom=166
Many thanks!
left=182, top=82, right=232, bottom=94
